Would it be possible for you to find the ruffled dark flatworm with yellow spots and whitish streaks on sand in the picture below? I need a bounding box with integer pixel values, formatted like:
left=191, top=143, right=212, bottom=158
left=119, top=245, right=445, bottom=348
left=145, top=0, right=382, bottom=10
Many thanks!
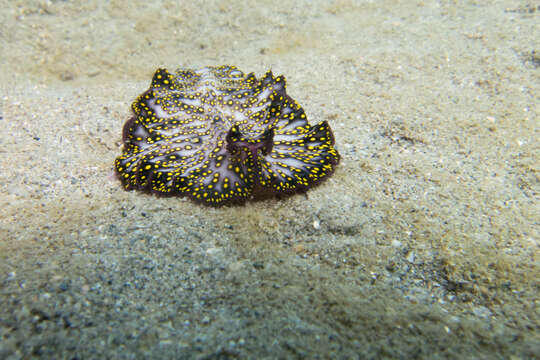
left=115, top=65, right=340, bottom=205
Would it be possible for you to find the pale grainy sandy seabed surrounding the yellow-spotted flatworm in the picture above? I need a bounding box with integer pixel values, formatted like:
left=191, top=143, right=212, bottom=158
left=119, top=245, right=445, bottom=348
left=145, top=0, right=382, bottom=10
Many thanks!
left=0, top=0, right=540, bottom=359
